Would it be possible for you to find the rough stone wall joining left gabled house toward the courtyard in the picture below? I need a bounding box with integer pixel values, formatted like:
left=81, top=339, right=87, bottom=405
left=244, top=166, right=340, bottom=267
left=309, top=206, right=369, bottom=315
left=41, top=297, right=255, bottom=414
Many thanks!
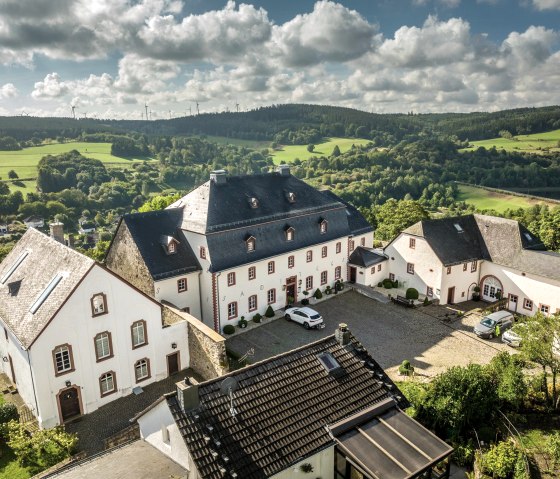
left=162, top=302, right=229, bottom=380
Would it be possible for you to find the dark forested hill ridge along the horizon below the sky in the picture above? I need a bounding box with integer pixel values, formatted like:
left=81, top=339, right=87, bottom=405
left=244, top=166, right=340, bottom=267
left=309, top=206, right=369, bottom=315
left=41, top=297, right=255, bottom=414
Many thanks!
left=0, top=104, right=560, bottom=145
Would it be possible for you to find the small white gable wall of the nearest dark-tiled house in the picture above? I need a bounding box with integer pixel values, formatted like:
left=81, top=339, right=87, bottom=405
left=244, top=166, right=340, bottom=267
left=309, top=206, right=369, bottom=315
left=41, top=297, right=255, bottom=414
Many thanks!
left=137, top=399, right=192, bottom=472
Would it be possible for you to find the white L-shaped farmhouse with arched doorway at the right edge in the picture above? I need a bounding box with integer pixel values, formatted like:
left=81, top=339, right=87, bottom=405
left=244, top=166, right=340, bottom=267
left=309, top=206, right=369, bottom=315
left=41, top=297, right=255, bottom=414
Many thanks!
left=384, top=214, right=560, bottom=315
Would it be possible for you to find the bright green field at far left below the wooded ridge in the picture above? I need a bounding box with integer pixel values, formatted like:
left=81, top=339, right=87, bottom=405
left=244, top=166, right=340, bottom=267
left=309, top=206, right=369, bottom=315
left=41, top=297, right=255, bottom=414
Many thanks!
left=0, top=142, right=153, bottom=193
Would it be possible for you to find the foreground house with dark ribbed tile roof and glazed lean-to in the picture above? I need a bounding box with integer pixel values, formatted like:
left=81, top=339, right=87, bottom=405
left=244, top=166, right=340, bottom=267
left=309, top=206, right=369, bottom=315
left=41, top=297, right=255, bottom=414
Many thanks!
left=135, top=324, right=452, bottom=479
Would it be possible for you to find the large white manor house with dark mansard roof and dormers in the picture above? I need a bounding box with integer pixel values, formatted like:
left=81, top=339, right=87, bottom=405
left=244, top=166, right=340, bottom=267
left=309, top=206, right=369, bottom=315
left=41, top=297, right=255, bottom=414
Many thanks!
left=106, top=165, right=373, bottom=332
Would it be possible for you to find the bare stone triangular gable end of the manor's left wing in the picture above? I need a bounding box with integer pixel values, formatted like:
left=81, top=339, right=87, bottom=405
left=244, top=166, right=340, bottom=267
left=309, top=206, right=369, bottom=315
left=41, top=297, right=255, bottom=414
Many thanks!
left=105, top=221, right=155, bottom=298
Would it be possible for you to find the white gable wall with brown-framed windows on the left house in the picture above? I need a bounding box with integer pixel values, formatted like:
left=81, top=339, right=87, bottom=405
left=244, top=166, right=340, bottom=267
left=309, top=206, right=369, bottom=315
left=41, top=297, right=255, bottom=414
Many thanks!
left=31, top=266, right=188, bottom=427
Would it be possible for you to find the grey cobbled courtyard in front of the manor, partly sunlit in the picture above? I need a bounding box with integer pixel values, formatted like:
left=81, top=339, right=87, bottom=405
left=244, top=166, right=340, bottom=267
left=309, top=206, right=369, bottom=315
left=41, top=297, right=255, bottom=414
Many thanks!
left=226, top=291, right=509, bottom=378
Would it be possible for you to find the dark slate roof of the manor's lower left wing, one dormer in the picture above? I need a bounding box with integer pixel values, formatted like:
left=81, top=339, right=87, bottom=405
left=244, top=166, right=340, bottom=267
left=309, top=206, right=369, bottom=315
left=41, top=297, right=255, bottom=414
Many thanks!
left=122, top=208, right=201, bottom=280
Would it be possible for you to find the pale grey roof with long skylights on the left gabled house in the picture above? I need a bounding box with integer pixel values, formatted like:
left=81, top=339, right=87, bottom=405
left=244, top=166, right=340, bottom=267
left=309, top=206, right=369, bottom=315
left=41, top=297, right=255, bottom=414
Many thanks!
left=0, top=228, right=95, bottom=347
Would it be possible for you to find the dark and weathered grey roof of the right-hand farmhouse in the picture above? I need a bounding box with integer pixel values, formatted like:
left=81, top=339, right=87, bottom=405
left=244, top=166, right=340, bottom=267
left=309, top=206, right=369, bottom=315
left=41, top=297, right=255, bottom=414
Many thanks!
left=404, top=214, right=560, bottom=280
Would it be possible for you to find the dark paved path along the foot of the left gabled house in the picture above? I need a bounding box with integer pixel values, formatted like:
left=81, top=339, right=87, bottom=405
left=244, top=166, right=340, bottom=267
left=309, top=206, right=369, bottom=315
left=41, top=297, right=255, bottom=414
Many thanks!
left=65, top=369, right=193, bottom=455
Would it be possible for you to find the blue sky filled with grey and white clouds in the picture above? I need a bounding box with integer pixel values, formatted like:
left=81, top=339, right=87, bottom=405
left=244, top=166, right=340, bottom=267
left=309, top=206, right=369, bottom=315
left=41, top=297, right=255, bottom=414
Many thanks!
left=0, top=0, right=560, bottom=120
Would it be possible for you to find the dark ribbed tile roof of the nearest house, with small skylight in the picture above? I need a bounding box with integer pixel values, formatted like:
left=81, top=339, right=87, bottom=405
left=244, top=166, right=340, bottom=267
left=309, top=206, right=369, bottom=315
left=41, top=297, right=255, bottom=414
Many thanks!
left=167, top=336, right=408, bottom=479
